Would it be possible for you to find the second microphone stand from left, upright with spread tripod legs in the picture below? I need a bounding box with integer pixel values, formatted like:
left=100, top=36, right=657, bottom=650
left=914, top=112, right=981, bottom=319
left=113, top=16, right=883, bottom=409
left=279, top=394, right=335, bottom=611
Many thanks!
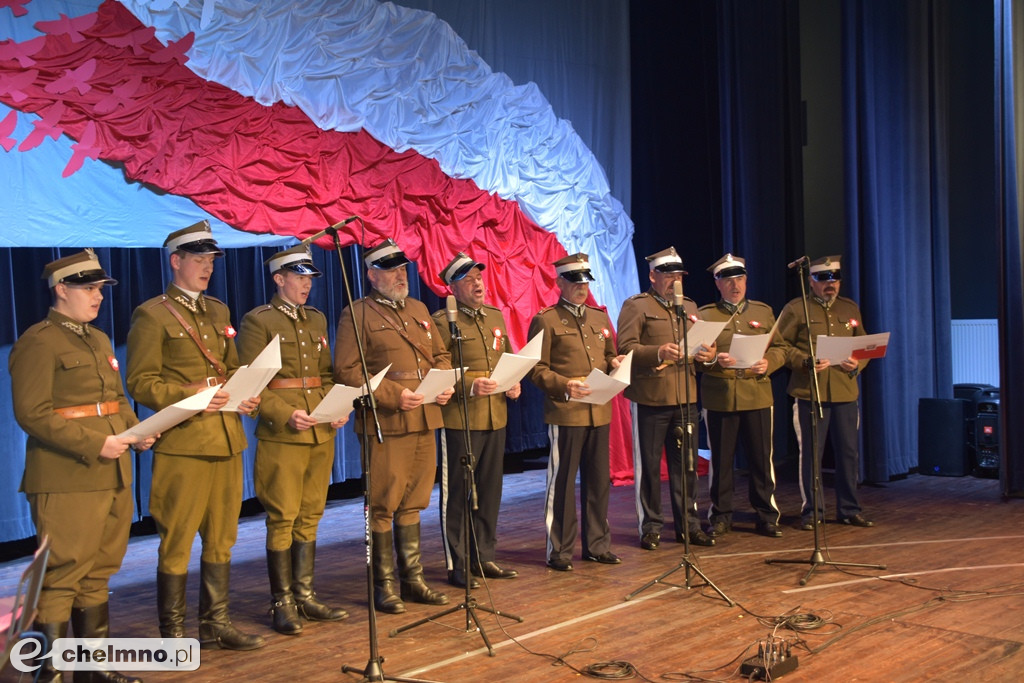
left=388, top=313, right=522, bottom=656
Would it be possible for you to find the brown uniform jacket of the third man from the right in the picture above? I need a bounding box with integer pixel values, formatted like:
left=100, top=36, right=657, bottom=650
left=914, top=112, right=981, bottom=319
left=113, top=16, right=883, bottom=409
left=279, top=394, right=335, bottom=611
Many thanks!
left=618, top=292, right=697, bottom=405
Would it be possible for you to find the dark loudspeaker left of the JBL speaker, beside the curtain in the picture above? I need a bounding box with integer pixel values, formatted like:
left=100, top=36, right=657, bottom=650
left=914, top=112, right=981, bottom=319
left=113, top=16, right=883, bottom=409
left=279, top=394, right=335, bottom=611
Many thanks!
left=918, top=398, right=969, bottom=477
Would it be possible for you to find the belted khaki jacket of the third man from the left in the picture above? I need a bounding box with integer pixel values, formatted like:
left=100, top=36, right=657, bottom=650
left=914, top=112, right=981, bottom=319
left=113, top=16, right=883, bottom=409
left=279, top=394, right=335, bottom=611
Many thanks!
left=238, top=295, right=335, bottom=444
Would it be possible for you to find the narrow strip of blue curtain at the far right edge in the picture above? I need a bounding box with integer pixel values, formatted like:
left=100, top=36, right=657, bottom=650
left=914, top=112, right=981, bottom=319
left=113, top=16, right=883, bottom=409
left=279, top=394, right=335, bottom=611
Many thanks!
left=993, top=0, right=1024, bottom=497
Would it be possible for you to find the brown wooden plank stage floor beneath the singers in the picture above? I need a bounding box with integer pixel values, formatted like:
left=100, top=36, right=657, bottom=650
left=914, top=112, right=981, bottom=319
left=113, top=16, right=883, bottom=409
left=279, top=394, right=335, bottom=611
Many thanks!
left=0, top=462, right=1024, bottom=683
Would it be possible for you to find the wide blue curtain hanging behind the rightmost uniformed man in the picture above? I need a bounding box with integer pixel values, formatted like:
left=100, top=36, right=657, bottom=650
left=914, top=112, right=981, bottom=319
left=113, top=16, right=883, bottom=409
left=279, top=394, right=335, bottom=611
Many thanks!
left=843, top=0, right=952, bottom=481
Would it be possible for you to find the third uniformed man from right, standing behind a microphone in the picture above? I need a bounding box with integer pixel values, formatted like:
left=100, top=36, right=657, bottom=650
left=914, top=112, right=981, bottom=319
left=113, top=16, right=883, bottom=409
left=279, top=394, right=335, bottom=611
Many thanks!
left=618, top=247, right=715, bottom=550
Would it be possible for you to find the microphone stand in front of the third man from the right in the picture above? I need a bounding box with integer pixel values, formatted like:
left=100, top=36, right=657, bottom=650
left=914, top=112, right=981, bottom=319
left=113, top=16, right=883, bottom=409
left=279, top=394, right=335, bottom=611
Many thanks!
left=625, top=279, right=736, bottom=607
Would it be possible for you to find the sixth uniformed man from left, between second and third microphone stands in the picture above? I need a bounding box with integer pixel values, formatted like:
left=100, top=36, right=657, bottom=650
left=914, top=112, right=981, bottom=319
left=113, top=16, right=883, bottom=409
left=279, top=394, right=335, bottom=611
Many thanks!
left=529, top=254, right=623, bottom=571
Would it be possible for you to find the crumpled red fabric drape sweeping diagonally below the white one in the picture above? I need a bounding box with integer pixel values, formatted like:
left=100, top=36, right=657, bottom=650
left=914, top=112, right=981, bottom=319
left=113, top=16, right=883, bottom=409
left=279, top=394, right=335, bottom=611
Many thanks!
left=0, top=0, right=632, bottom=478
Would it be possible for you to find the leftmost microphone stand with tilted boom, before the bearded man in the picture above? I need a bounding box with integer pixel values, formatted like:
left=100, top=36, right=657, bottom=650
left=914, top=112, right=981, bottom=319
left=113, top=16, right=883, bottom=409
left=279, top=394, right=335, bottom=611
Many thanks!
left=327, top=228, right=438, bottom=683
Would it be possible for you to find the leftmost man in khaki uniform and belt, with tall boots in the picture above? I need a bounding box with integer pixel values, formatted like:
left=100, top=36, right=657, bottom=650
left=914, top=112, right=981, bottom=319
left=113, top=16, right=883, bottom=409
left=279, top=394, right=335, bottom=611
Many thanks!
left=8, top=249, right=154, bottom=682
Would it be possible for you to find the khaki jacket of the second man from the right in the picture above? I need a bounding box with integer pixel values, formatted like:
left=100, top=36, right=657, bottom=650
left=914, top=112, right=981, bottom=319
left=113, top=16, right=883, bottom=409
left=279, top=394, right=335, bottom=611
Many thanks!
left=697, top=299, right=787, bottom=413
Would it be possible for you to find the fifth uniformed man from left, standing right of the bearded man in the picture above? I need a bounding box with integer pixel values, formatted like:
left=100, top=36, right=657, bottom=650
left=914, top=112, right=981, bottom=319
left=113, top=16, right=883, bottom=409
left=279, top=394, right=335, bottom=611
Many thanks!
left=434, top=252, right=520, bottom=588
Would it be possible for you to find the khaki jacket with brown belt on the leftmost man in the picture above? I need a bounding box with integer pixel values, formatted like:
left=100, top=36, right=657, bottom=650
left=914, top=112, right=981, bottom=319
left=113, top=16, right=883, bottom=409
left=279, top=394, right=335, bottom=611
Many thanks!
left=8, top=309, right=138, bottom=494
